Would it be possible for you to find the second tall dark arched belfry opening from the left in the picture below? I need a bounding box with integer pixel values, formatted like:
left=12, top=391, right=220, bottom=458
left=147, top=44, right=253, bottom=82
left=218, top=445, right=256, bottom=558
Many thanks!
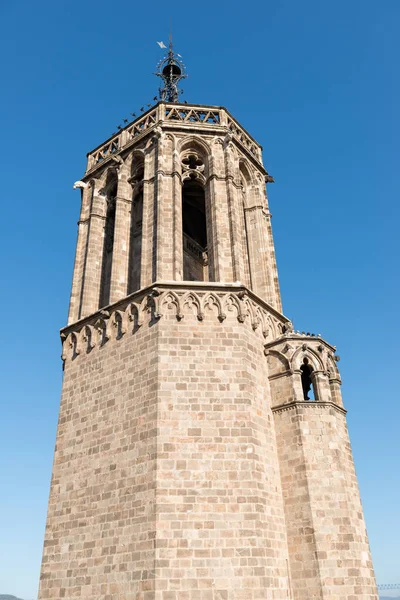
left=128, top=159, right=144, bottom=294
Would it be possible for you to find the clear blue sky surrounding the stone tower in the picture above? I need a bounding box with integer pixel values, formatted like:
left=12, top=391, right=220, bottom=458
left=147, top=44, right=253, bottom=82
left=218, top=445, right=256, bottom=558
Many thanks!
left=0, top=0, right=400, bottom=600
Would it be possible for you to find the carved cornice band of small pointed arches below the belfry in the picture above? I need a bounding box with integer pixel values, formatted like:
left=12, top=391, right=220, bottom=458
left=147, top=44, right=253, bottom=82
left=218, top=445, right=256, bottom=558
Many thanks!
left=61, top=282, right=288, bottom=360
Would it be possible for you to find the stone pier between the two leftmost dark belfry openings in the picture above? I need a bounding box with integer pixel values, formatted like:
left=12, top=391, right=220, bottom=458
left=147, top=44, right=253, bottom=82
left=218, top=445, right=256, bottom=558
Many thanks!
left=110, top=166, right=132, bottom=303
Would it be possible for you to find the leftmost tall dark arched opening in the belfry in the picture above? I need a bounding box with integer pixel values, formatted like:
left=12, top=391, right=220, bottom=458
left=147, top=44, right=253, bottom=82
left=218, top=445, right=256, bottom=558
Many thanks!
left=99, top=172, right=118, bottom=308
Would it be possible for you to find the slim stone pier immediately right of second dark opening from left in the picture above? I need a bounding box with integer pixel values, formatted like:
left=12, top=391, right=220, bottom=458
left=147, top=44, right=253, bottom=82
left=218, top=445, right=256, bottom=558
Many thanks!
left=140, top=145, right=155, bottom=288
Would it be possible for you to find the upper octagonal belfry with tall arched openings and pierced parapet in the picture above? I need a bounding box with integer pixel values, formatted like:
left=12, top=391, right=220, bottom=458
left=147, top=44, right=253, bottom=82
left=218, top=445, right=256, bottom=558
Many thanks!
left=69, top=102, right=281, bottom=323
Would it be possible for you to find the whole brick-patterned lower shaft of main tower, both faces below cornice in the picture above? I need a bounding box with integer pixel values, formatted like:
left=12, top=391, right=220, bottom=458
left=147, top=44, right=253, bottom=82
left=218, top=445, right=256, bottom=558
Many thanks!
left=39, top=288, right=289, bottom=600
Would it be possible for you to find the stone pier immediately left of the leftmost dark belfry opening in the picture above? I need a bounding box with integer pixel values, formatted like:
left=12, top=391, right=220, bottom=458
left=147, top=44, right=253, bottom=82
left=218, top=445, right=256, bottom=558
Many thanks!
left=80, top=189, right=106, bottom=318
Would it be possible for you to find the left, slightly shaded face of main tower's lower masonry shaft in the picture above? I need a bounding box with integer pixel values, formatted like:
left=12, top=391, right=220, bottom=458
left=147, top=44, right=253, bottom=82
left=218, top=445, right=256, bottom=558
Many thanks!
left=39, top=327, right=158, bottom=600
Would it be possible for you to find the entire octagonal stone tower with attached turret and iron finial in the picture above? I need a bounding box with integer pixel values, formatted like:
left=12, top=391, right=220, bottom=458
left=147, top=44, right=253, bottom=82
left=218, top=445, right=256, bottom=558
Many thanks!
left=39, top=46, right=377, bottom=600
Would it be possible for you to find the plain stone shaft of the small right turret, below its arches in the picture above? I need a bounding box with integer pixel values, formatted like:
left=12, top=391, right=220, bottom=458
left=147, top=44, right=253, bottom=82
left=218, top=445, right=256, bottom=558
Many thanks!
left=274, top=402, right=377, bottom=600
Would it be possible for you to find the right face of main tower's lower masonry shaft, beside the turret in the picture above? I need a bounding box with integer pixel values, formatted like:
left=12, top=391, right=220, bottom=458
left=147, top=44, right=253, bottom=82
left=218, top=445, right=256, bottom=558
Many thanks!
left=156, top=307, right=289, bottom=600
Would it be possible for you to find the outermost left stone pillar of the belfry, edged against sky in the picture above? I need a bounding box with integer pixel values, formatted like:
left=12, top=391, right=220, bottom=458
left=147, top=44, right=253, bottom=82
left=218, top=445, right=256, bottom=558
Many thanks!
left=68, top=185, right=93, bottom=324
